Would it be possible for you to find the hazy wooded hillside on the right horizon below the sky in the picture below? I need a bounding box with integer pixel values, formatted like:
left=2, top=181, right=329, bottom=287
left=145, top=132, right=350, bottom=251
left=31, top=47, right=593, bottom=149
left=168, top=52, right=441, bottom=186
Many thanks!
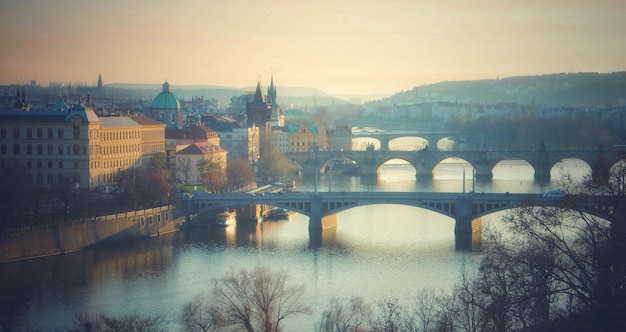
left=372, top=72, right=626, bottom=106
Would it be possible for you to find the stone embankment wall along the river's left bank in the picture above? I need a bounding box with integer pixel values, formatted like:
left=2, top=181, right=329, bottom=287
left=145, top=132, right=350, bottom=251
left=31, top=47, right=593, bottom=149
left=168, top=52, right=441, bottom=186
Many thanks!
left=0, top=205, right=185, bottom=263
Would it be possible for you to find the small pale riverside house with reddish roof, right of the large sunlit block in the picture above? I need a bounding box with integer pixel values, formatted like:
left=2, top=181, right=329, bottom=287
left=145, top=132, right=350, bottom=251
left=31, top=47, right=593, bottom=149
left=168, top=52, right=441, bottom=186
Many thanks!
left=176, top=143, right=228, bottom=184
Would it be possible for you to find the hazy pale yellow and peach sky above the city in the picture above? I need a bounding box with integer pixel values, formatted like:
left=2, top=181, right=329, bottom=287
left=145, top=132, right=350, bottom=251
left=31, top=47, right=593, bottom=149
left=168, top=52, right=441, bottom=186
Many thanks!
left=0, top=0, right=626, bottom=94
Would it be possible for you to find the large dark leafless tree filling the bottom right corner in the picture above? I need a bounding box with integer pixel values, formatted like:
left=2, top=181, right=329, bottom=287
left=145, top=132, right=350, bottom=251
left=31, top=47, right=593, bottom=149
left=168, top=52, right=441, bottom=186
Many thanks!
left=454, top=167, right=626, bottom=331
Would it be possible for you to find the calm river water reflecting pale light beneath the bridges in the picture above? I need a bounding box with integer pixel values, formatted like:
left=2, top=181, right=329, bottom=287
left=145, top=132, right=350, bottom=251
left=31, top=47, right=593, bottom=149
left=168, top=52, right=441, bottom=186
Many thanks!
left=0, top=160, right=589, bottom=331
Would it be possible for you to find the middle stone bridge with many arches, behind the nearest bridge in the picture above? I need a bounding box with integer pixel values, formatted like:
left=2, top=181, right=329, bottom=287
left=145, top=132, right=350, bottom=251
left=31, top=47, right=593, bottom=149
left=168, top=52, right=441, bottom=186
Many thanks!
left=286, top=149, right=626, bottom=181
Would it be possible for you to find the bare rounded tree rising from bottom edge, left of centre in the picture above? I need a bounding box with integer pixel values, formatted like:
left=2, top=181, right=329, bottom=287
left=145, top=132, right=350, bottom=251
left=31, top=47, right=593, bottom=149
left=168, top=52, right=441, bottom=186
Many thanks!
left=214, top=267, right=309, bottom=332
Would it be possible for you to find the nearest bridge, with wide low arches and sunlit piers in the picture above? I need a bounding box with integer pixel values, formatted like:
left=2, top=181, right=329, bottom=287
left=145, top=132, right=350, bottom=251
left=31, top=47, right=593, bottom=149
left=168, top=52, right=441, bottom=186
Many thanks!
left=185, top=192, right=612, bottom=250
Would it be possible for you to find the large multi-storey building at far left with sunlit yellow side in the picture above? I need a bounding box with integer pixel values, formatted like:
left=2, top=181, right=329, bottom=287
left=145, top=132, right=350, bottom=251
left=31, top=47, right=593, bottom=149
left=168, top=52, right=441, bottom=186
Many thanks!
left=0, top=101, right=165, bottom=188
